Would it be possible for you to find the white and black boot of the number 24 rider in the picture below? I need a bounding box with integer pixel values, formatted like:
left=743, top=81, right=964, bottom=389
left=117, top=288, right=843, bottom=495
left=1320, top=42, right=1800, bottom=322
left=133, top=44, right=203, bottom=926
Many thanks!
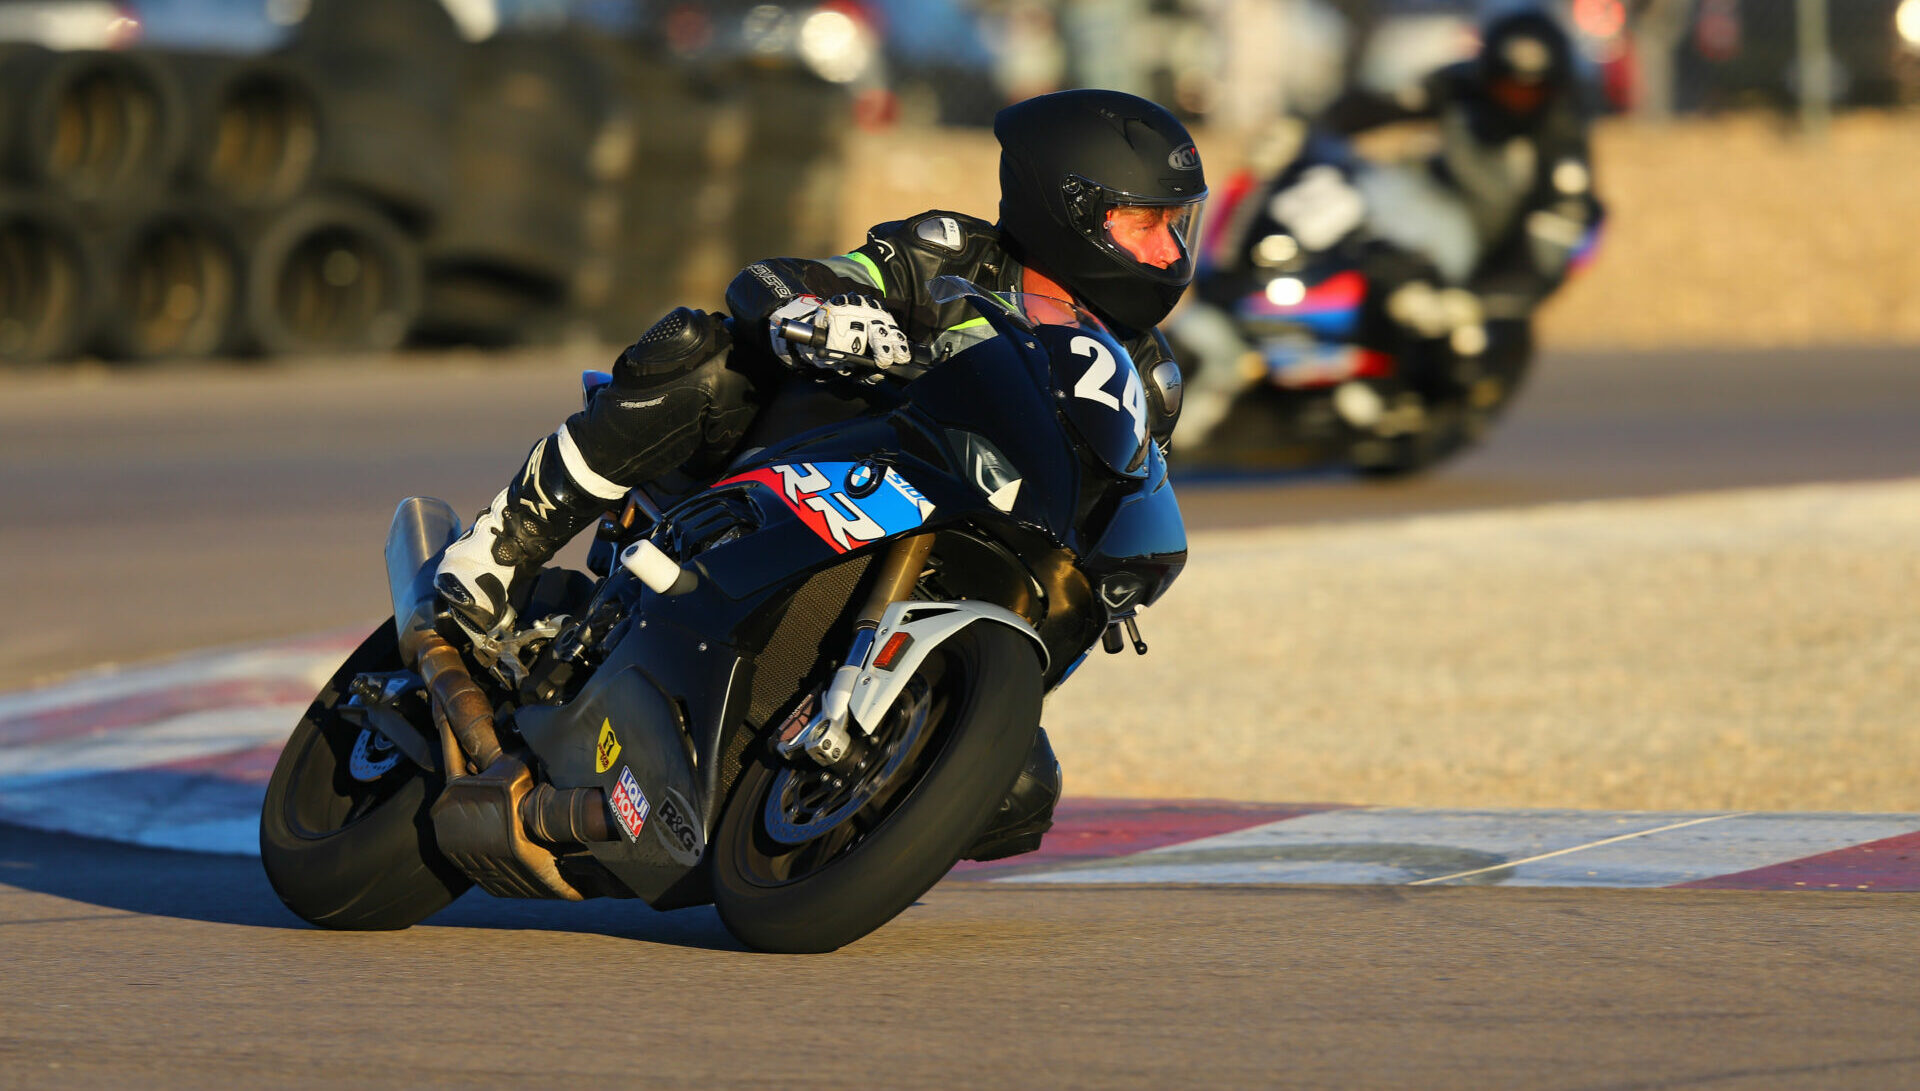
left=434, top=424, right=626, bottom=634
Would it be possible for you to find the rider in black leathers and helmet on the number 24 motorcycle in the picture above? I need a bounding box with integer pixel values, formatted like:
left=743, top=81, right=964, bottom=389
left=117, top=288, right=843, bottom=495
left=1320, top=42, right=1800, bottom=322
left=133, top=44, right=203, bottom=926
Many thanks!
left=436, top=90, right=1208, bottom=859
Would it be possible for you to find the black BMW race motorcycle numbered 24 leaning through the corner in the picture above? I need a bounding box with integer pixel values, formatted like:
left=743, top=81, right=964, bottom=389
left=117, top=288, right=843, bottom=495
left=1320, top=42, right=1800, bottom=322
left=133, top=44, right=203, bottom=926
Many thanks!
left=261, top=277, right=1187, bottom=951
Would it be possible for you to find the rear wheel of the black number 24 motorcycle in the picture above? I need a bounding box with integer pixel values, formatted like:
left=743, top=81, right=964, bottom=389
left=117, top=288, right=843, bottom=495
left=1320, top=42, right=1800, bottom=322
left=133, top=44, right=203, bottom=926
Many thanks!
left=259, top=624, right=472, bottom=930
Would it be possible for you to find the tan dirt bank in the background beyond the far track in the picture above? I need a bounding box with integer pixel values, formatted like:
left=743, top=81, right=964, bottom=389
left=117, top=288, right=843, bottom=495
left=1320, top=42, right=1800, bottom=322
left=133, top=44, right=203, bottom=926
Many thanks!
left=843, top=111, right=1920, bottom=348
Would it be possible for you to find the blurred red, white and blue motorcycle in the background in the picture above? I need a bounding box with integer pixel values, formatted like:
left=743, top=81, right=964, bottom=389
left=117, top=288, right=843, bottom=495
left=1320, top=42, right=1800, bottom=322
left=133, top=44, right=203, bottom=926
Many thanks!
left=1167, top=133, right=1597, bottom=476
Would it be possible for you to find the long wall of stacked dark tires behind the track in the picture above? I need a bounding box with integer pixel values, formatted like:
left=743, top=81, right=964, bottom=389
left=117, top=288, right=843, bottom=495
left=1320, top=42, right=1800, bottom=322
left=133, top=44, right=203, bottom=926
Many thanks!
left=0, top=13, right=852, bottom=363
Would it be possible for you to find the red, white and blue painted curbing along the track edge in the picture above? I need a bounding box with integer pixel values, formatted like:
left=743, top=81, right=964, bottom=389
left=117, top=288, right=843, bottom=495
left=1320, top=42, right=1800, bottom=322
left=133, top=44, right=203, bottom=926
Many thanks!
left=0, top=634, right=1920, bottom=891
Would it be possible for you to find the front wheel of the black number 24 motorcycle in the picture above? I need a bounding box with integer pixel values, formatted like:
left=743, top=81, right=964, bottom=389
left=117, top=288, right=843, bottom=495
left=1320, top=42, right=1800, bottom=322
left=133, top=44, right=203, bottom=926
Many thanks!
left=714, top=622, right=1041, bottom=953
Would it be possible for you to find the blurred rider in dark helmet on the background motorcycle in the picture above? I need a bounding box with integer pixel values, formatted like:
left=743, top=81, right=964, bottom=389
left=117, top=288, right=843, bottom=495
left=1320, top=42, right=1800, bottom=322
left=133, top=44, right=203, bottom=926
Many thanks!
left=1179, top=8, right=1603, bottom=444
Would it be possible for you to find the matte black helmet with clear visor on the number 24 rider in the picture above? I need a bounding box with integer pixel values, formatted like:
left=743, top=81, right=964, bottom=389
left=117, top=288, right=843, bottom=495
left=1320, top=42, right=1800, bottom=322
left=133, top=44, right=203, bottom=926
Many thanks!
left=993, top=90, right=1206, bottom=330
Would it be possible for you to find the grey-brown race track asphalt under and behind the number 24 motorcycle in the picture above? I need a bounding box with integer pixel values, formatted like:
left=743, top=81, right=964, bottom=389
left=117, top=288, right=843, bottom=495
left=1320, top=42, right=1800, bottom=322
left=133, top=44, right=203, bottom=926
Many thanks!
left=0, top=350, right=1920, bottom=1089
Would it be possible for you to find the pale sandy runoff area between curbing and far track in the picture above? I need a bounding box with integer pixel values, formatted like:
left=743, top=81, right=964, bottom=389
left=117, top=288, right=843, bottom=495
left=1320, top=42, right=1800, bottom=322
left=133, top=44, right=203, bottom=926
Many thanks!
left=1044, top=478, right=1920, bottom=812
